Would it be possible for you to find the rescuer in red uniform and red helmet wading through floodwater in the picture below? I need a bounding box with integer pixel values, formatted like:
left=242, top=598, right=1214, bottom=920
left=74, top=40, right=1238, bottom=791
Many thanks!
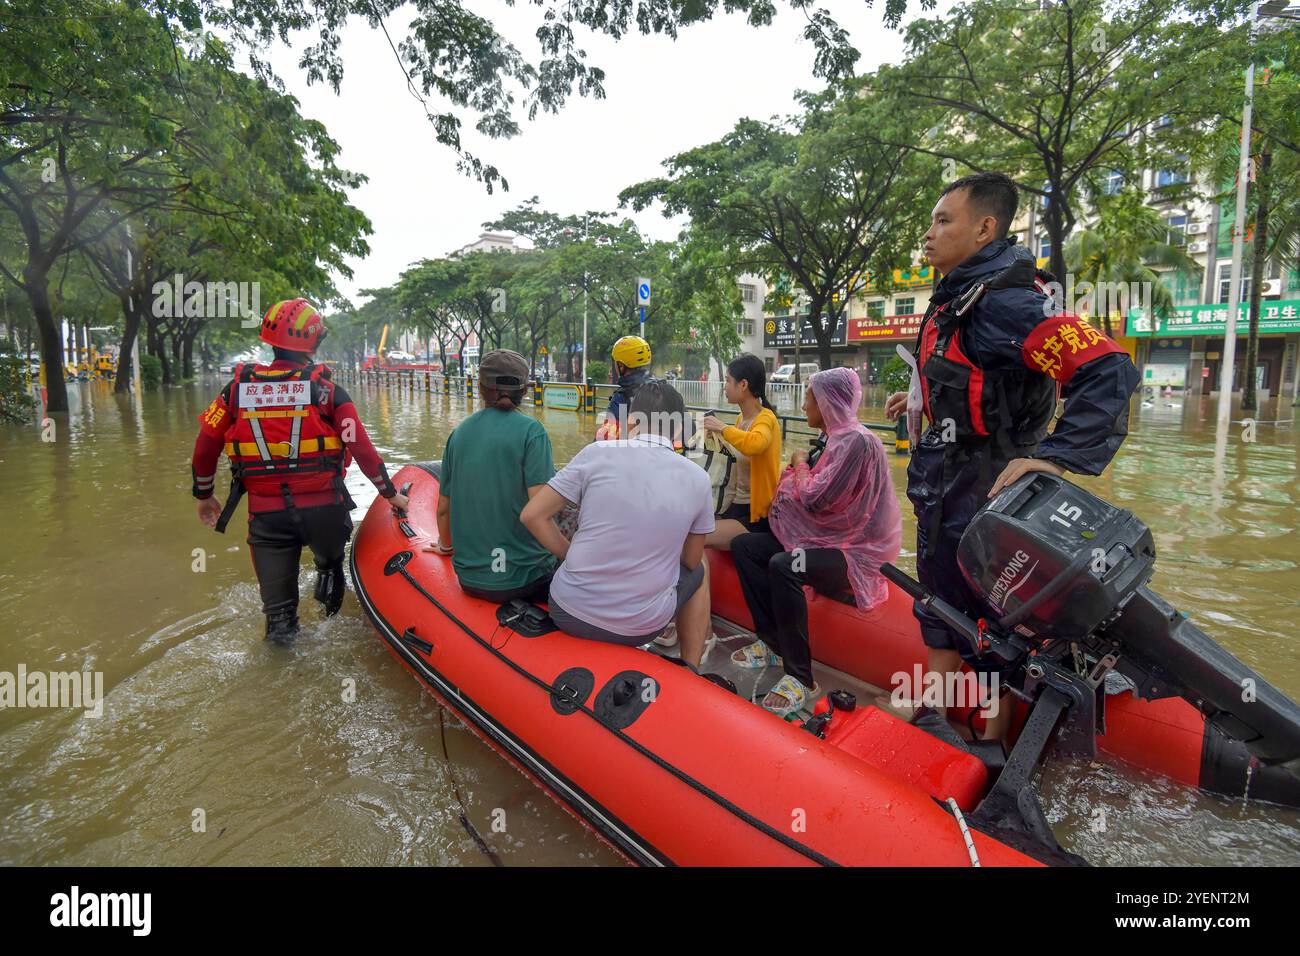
left=191, top=299, right=407, bottom=643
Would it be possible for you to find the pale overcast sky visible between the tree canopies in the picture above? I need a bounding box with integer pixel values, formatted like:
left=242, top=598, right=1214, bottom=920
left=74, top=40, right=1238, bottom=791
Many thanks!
left=256, top=0, right=952, bottom=304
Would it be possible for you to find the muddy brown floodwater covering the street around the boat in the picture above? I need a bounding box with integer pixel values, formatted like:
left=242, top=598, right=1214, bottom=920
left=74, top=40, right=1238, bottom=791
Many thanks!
left=0, top=380, right=1300, bottom=865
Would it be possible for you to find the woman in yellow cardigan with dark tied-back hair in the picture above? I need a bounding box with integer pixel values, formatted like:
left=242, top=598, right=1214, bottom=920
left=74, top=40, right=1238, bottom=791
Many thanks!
left=699, top=355, right=781, bottom=550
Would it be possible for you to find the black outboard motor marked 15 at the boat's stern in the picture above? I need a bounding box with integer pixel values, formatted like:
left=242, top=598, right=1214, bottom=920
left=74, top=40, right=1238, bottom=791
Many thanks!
left=957, top=472, right=1300, bottom=803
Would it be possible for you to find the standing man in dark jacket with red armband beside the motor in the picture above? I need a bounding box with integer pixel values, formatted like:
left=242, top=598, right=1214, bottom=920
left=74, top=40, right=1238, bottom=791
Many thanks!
left=885, top=173, right=1138, bottom=736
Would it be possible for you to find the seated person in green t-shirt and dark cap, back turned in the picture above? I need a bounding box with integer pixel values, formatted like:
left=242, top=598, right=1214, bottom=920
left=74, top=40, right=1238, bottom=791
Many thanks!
left=425, top=349, right=555, bottom=604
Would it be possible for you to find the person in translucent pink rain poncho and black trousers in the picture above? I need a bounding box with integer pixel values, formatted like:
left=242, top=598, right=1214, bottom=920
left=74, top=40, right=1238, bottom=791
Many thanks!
left=732, top=368, right=902, bottom=717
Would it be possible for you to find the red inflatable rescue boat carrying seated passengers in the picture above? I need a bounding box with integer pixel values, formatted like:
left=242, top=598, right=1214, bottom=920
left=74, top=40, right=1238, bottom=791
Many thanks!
left=351, top=464, right=1300, bottom=866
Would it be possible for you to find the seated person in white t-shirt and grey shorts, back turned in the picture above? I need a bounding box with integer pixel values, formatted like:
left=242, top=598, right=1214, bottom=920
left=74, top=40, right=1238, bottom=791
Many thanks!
left=520, top=378, right=714, bottom=667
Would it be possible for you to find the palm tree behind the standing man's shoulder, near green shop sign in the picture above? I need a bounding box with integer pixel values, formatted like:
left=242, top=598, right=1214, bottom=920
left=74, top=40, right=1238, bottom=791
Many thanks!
left=1065, top=189, right=1201, bottom=336
